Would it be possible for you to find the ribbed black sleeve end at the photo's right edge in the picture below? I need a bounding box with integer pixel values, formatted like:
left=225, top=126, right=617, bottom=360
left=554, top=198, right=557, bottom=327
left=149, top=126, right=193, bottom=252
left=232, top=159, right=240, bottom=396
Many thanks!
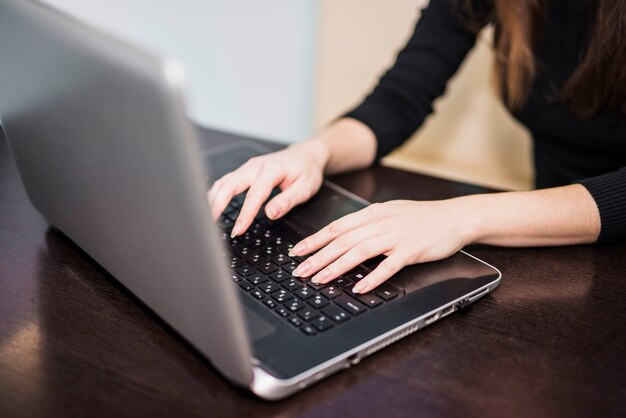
left=577, top=167, right=626, bottom=243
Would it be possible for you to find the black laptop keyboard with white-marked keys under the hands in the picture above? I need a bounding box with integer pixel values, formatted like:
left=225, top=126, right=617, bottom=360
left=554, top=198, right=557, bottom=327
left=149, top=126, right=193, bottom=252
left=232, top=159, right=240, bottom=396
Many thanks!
left=217, top=195, right=402, bottom=336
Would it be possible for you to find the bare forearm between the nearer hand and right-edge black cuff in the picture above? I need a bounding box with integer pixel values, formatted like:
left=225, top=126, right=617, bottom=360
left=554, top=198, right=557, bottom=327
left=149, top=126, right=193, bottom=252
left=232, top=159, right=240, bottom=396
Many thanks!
left=454, top=184, right=600, bottom=247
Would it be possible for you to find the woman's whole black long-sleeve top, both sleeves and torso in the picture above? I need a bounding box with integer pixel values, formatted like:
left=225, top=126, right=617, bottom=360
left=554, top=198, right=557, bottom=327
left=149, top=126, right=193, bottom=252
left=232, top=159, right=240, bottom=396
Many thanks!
left=345, top=0, right=626, bottom=242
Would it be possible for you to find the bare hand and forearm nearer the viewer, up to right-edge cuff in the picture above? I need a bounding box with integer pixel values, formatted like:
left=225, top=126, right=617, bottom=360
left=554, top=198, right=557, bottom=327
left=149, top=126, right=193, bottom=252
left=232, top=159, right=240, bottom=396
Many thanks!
left=290, top=184, right=601, bottom=293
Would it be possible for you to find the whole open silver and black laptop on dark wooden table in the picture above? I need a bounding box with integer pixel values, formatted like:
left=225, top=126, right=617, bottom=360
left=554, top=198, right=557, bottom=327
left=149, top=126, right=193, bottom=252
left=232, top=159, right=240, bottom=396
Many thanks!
left=0, top=0, right=501, bottom=400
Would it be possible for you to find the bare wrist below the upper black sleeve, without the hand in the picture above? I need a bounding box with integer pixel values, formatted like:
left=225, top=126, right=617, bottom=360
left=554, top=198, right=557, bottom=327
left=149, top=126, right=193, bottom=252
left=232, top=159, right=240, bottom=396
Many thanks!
left=302, top=118, right=376, bottom=174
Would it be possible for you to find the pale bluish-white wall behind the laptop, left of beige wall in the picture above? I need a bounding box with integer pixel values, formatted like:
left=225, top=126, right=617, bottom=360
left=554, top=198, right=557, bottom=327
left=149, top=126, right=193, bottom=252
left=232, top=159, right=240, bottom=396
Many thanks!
left=45, top=0, right=317, bottom=142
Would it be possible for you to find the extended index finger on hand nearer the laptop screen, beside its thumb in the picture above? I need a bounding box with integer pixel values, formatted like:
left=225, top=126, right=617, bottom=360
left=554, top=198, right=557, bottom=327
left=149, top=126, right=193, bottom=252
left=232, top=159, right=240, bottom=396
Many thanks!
left=231, top=164, right=284, bottom=237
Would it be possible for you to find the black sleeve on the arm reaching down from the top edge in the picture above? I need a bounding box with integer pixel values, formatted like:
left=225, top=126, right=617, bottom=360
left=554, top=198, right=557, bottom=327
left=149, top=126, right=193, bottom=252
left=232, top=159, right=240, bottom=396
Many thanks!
left=344, top=0, right=488, bottom=160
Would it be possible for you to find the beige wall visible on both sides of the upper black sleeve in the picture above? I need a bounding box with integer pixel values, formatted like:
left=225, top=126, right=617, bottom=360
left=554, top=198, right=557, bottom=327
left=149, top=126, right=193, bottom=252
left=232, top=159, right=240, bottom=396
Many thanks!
left=315, top=0, right=532, bottom=189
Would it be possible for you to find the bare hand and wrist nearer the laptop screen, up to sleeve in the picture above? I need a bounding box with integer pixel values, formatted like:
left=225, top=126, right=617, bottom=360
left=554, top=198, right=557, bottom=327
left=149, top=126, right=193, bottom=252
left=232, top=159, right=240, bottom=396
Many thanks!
left=208, top=118, right=376, bottom=237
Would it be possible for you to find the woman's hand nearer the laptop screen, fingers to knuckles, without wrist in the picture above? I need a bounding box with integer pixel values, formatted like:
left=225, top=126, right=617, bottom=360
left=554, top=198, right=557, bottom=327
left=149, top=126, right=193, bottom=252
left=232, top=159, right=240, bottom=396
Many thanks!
left=208, top=141, right=329, bottom=237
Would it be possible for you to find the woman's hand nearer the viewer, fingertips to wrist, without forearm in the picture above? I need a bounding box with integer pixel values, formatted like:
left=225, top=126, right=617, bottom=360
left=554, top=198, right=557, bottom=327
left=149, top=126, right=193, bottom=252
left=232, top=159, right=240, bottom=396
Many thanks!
left=290, top=199, right=472, bottom=293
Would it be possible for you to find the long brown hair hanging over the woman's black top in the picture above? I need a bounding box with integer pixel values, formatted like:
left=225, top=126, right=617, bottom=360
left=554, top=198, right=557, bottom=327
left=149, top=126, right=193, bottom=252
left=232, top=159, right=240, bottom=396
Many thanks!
left=463, top=0, right=626, bottom=118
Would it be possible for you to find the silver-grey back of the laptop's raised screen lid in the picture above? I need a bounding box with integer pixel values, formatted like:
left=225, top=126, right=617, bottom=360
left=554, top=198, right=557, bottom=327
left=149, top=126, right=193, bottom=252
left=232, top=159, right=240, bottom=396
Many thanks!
left=0, top=0, right=253, bottom=386
